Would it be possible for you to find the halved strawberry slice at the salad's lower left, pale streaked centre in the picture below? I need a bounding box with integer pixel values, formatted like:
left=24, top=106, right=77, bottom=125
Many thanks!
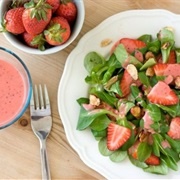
left=107, top=123, right=131, bottom=151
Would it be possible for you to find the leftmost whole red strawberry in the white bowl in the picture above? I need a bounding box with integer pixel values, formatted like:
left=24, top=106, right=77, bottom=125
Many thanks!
left=2, top=7, right=25, bottom=34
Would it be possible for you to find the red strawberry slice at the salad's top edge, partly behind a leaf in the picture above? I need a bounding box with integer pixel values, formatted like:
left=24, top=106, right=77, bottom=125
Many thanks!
left=111, top=38, right=146, bottom=54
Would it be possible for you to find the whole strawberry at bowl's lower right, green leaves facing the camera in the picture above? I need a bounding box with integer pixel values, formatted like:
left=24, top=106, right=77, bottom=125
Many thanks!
left=44, top=16, right=71, bottom=46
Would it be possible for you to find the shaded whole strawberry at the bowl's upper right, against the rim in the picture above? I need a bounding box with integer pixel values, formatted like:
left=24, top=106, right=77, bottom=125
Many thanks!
left=56, top=0, right=77, bottom=25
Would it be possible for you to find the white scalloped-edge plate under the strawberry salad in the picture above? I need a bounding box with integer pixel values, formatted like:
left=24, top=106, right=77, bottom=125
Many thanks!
left=58, top=9, right=180, bottom=179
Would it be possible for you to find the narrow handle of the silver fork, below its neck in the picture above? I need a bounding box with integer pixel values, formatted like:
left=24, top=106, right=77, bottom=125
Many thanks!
left=40, top=139, right=51, bottom=180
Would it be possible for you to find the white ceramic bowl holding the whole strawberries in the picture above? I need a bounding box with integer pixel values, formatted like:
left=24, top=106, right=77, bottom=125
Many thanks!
left=0, top=0, right=85, bottom=55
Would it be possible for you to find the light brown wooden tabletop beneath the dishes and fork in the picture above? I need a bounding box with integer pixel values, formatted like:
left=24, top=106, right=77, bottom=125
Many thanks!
left=0, top=0, right=180, bottom=180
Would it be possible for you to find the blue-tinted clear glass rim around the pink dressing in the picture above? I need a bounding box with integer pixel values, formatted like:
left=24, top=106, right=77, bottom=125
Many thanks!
left=0, top=46, right=32, bottom=129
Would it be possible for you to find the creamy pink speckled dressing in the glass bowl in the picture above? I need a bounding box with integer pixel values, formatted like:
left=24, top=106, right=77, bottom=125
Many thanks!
left=0, top=59, right=26, bottom=126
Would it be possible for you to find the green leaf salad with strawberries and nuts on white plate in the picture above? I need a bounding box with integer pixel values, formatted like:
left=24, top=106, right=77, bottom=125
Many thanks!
left=77, top=27, right=180, bottom=175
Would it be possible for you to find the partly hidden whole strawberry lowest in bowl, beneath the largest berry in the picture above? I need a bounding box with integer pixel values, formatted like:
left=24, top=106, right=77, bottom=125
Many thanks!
left=22, top=32, right=46, bottom=51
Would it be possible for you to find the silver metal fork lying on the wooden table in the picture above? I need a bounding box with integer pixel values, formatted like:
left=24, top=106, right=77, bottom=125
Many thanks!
left=30, top=85, right=52, bottom=180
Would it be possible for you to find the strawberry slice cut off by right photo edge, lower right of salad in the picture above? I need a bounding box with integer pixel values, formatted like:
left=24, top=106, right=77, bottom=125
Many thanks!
left=167, top=117, right=180, bottom=139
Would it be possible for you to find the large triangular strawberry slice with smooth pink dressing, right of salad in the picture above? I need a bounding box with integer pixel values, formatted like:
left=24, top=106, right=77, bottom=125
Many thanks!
left=147, top=81, right=179, bottom=105
